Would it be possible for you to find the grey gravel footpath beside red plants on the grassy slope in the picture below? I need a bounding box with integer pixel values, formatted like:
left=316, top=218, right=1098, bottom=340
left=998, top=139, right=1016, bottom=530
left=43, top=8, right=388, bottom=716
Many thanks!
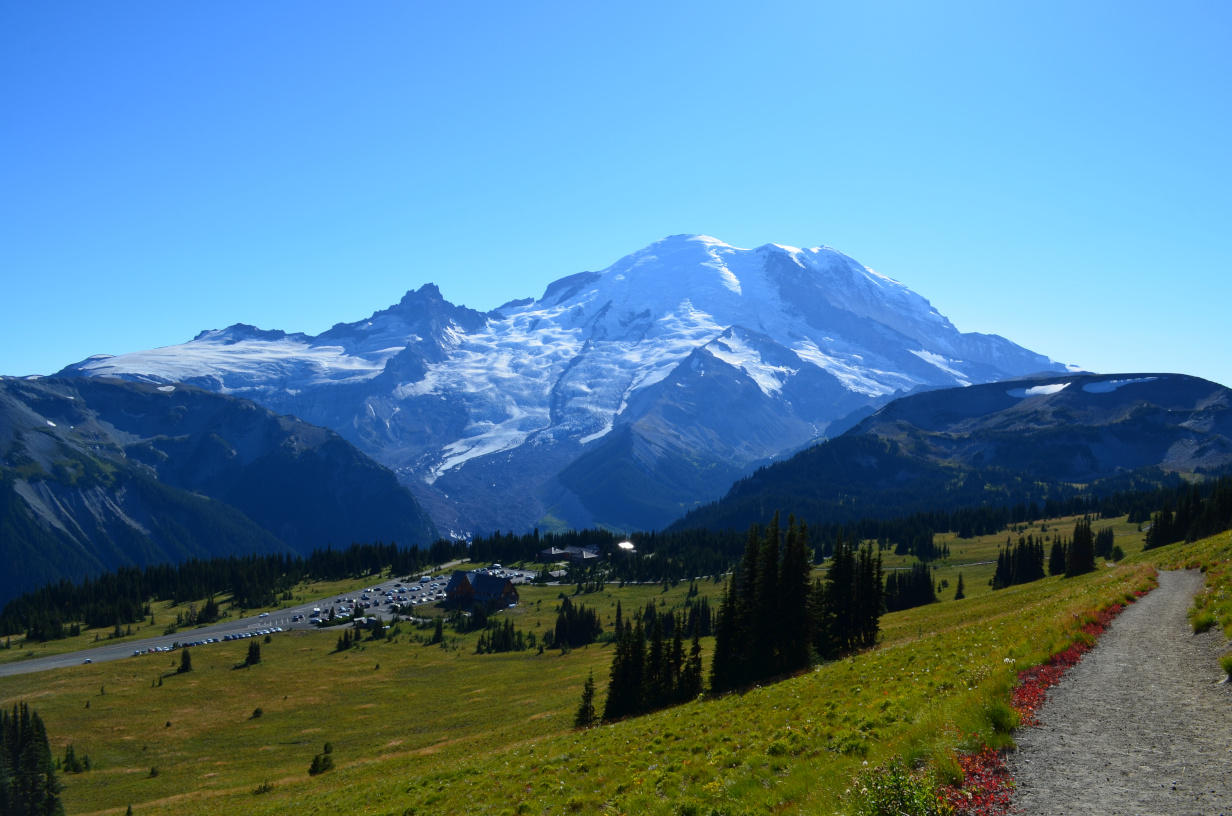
left=1009, top=569, right=1232, bottom=816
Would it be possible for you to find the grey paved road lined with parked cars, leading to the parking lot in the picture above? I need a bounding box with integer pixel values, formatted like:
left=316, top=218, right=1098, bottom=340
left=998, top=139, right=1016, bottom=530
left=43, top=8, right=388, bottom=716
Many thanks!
left=0, top=578, right=438, bottom=677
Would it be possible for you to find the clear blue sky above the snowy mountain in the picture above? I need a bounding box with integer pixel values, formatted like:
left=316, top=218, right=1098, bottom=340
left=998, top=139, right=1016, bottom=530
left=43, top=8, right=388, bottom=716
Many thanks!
left=0, top=0, right=1232, bottom=385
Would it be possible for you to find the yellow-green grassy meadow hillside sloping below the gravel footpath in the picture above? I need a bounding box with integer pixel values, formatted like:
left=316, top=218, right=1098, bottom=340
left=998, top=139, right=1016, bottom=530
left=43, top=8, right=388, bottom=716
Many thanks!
left=7, top=523, right=1212, bottom=816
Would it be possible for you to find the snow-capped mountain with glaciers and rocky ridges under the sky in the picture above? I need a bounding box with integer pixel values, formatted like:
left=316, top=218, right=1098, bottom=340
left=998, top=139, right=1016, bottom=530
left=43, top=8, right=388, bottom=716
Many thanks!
left=62, top=235, right=1066, bottom=532
